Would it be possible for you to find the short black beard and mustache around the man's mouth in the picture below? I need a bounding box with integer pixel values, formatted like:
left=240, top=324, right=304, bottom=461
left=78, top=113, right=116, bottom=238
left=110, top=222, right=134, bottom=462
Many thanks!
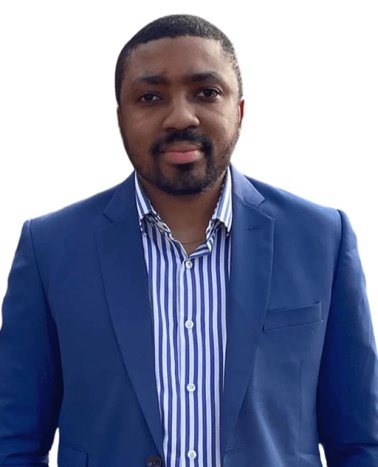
left=121, top=127, right=239, bottom=196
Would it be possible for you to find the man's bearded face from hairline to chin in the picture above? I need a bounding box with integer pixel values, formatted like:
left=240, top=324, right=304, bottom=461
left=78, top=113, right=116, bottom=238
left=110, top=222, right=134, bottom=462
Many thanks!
left=118, top=36, right=243, bottom=195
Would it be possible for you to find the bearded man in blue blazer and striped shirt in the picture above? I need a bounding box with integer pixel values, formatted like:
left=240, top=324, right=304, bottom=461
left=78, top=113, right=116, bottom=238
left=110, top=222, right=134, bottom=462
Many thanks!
left=0, top=15, right=378, bottom=467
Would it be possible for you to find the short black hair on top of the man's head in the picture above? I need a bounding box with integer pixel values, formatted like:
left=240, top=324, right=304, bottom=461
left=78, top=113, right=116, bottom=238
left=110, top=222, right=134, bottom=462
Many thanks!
left=115, top=15, right=243, bottom=105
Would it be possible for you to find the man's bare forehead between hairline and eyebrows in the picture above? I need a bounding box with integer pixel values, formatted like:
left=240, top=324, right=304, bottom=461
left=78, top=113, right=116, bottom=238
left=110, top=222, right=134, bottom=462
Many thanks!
left=124, top=36, right=238, bottom=88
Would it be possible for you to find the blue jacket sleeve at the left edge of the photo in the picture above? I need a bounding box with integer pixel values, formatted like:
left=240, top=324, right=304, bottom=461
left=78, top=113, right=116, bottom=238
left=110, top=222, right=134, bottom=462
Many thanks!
left=0, top=222, right=62, bottom=467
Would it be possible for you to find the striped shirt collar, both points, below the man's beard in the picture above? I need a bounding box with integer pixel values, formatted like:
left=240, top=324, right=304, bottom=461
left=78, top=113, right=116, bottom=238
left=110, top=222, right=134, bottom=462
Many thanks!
left=134, top=168, right=232, bottom=234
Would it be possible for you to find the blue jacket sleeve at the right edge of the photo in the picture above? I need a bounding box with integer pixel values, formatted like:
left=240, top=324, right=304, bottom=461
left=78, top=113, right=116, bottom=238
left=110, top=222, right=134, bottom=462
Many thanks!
left=317, top=213, right=378, bottom=467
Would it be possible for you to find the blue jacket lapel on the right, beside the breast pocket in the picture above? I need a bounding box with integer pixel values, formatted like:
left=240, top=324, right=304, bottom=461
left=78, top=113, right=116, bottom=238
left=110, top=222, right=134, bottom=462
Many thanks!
left=221, top=169, right=274, bottom=455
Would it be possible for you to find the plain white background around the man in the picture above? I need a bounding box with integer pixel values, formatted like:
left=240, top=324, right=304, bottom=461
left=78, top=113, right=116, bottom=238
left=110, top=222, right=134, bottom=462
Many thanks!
left=0, top=0, right=378, bottom=465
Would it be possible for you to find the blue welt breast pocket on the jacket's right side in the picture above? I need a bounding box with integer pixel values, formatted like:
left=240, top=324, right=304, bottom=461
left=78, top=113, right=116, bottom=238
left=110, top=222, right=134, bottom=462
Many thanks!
left=263, top=302, right=323, bottom=331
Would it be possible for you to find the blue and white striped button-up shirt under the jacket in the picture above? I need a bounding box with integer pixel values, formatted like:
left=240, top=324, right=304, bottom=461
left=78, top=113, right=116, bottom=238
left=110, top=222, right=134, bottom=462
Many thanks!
left=135, top=170, right=232, bottom=467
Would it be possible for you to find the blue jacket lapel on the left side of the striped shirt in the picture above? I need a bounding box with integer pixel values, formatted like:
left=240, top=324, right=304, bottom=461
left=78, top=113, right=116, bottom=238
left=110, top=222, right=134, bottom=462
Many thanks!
left=96, top=176, right=163, bottom=455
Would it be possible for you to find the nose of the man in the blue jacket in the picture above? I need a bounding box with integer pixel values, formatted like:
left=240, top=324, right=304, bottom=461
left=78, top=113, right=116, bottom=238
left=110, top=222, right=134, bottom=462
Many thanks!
left=163, top=96, right=200, bottom=131
